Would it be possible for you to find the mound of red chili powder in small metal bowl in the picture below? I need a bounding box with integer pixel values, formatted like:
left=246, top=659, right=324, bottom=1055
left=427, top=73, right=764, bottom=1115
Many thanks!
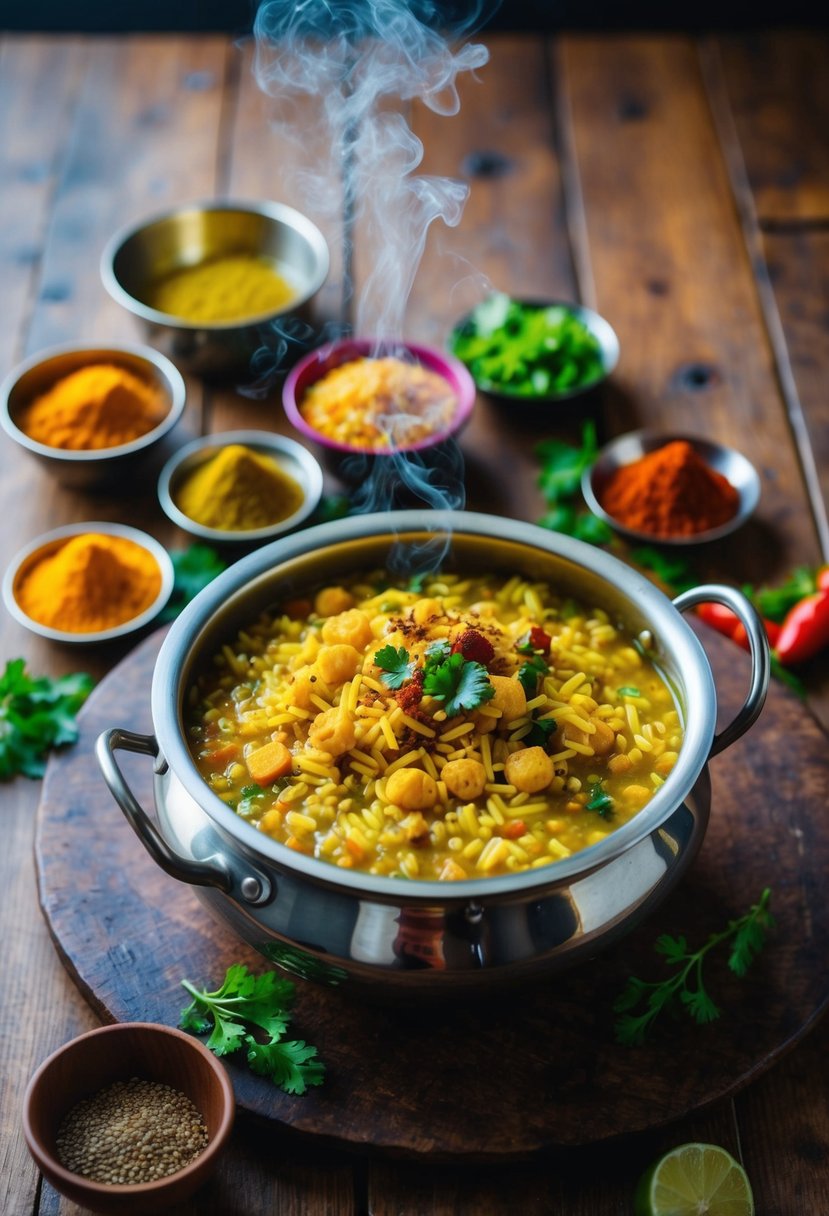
left=599, top=439, right=739, bottom=536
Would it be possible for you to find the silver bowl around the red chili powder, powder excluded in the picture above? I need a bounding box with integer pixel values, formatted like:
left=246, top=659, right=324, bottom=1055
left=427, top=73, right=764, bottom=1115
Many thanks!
left=581, top=430, right=760, bottom=545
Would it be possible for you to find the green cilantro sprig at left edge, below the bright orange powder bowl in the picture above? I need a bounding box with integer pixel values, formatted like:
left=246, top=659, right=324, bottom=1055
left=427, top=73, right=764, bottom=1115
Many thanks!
left=0, top=659, right=92, bottom=781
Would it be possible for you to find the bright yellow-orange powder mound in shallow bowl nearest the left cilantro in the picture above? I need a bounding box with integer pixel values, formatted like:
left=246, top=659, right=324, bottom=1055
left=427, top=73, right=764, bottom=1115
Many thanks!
left=15, top=533, right=162, bottom=634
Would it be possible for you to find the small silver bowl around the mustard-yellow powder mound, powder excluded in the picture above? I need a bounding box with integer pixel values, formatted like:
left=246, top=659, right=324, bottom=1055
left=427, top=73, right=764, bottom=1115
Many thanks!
left=158, top=430, right=322, bottom=545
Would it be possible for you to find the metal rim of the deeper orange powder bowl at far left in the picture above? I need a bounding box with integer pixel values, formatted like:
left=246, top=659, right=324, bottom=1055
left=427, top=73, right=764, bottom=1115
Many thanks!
left=0, top=342, right=187, bottom=465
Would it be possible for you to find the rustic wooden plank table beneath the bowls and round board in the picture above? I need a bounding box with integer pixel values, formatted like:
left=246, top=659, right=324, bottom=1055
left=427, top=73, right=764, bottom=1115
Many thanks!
left=0, top=32, right=829, bottom=1216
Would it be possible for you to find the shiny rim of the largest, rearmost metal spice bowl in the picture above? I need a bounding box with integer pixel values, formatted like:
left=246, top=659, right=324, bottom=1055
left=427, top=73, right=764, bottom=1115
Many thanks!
left=100, top=198, right=331, bottom=334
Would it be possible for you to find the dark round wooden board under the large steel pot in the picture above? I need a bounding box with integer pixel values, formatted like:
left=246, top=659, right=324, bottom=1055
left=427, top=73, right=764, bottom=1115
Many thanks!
left=36, top=630, right=829, bottom=1159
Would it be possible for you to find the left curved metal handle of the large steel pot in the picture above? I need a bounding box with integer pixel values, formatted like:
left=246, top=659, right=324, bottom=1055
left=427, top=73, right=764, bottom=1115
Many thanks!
left=95, top=727, right=233, bottom=894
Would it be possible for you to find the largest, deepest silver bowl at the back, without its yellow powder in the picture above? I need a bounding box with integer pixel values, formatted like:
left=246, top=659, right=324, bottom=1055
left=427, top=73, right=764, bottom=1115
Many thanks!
left=101, top=199, right=329, bottom=376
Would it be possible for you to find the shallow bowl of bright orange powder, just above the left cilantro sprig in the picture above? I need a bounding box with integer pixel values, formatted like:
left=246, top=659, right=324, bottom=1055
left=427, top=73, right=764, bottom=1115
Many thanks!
left=2, top=520, right=174, bottom=644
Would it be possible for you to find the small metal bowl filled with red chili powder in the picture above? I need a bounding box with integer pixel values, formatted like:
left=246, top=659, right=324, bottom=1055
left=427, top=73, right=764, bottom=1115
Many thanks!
left=581, top=430, right=760, bottom=545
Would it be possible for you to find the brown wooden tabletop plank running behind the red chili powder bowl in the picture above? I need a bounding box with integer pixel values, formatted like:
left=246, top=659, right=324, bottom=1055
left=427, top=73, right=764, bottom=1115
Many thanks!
left=563, top=36, right=818, bottom=581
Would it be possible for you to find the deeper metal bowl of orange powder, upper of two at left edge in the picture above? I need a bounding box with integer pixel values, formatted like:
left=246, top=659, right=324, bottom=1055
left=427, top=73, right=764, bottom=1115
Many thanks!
left=0, top=343, right=186, bottom=489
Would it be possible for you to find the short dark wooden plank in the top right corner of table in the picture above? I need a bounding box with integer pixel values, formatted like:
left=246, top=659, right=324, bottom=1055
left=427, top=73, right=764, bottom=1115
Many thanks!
left=717, top=29, right=829, bottom=226
